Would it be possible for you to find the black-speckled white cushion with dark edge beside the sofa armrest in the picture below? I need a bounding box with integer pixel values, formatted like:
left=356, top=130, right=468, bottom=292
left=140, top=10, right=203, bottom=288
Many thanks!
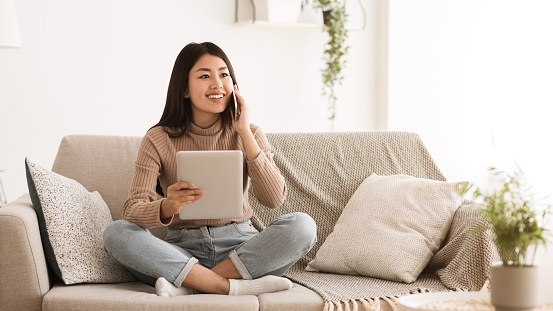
left=25, top=159, right=136, bottom=284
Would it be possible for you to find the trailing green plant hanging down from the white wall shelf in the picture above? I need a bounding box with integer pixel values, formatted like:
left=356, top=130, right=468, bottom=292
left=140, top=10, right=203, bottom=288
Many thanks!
left=302, top=0, right=349, bottom=129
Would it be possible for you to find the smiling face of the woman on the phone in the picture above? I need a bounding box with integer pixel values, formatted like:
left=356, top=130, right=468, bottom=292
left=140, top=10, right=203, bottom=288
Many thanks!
left=185, top=54, right=233, bottom=126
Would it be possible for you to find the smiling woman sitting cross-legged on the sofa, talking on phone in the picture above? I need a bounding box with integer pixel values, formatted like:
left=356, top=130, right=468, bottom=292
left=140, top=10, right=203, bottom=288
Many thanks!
left=104, top=42, right=316, bottom=296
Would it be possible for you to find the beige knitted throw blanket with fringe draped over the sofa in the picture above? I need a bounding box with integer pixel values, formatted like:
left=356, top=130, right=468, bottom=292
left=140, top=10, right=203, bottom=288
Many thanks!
left=249, top=131, right=497, bottom=310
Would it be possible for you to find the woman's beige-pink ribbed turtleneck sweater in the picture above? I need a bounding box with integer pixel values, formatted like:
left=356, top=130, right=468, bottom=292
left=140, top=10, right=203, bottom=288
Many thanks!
left=123, top=120, right=286, bottom=229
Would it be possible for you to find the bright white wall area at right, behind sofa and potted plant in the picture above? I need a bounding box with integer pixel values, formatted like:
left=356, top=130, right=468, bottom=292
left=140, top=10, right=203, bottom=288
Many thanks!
left=388, top=0, right=553, bottom=295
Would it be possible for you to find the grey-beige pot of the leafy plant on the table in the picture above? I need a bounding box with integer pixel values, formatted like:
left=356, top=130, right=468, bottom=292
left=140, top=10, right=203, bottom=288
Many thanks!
left=490, top=262, right=539, bottom=311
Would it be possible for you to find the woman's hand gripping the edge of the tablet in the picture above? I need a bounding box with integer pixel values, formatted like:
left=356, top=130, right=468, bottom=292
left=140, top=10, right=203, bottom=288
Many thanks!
left=160, top=182, right=204, bottom=222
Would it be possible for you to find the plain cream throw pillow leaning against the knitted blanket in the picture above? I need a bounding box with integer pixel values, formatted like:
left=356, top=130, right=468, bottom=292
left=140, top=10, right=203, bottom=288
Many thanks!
left=306, top=173, right=463, bottom=283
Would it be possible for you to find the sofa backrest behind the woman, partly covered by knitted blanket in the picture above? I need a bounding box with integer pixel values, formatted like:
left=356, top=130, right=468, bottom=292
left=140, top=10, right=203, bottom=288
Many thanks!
left=48, top=131, right=445, bottom=245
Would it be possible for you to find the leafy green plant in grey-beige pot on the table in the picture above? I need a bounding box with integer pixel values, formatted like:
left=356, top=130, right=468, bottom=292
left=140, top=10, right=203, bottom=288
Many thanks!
left=463, top=168, right=551, bottom=310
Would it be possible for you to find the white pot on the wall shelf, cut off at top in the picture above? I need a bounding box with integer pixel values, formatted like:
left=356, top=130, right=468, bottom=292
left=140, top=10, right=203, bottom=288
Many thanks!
left=254, top=0, right=301, bottom=24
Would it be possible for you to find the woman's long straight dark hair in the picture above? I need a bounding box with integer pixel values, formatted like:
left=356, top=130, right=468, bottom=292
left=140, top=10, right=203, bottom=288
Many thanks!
left=153, top=42, right=237, bottom=137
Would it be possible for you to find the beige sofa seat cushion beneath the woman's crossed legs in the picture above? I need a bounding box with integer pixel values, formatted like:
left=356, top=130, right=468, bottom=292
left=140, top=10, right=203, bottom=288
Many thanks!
left=43, top=282, right=392, bottom=311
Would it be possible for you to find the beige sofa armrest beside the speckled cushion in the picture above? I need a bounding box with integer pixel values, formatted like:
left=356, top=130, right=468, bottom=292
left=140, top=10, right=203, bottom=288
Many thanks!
left=0, top=194, right=50, bottom=311
